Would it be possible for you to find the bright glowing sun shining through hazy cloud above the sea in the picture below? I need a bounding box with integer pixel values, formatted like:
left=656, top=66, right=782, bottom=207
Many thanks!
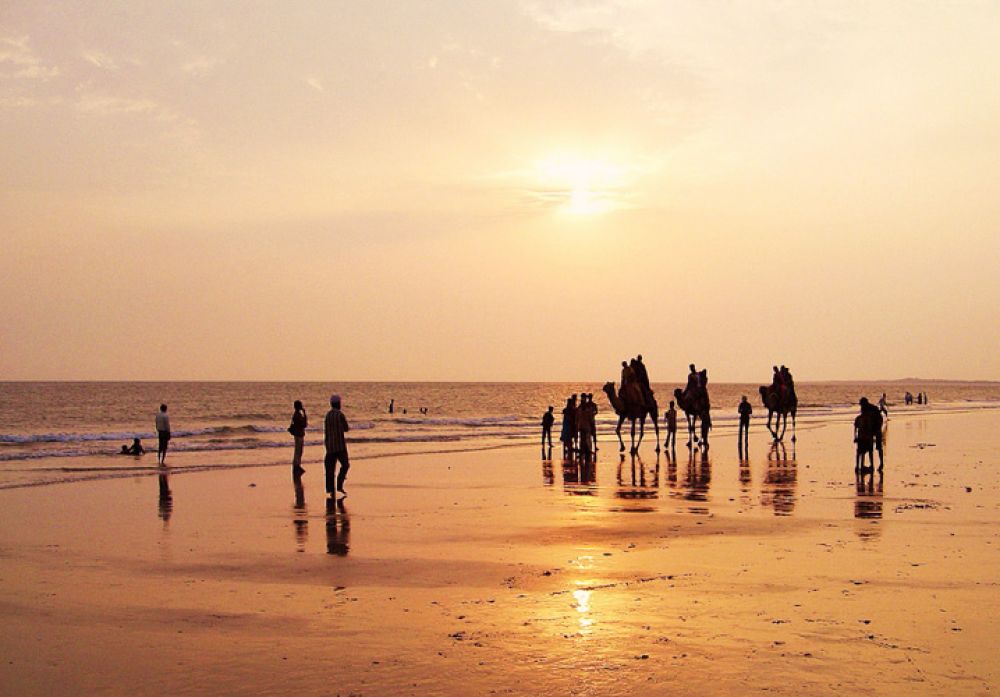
left=535, top=155, right=625, bottom=216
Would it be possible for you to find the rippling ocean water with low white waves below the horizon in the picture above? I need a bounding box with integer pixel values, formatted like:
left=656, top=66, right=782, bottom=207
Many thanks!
left=0, top=381, right=1000, bottom=488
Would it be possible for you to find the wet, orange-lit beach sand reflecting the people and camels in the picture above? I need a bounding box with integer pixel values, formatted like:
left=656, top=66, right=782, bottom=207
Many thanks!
left=0, top=410, right=1000, bottom=695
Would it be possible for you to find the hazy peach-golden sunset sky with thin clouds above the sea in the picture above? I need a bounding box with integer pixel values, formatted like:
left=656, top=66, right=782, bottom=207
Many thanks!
left=0, top=0, right=1000, bottom=382
